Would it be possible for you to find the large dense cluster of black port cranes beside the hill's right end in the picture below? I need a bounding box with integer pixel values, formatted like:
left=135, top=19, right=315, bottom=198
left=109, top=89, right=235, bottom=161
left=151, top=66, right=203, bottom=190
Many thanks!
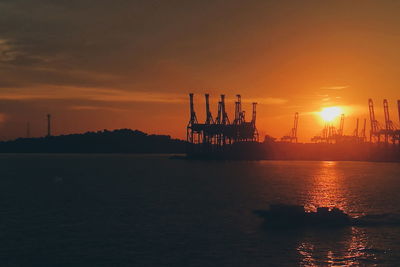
left=187, top=93, right=258, bottom=157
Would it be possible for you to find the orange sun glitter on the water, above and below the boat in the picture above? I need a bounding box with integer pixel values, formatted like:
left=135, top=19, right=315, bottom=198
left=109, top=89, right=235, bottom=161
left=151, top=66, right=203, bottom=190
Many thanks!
left=297, top=161, right=376, bottom=266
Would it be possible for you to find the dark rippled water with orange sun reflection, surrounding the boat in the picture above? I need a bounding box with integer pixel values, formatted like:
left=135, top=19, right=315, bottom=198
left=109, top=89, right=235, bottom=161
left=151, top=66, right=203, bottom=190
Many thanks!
left=0, top=155, right=400, bottom=266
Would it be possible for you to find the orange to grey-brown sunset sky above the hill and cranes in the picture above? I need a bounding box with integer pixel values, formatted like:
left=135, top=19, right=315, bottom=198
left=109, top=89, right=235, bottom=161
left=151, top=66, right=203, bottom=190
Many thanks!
left=0, top=0, right=400, bottom=142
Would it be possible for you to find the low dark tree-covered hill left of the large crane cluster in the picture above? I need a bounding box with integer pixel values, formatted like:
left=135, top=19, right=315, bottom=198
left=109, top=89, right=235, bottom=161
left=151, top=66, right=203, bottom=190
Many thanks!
left=0, top=129, right=186, bottom=153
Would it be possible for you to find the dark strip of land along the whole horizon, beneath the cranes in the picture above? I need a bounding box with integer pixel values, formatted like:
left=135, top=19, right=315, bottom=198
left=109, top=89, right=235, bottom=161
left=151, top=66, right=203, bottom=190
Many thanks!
left=0, top=129, right=400, bottom=161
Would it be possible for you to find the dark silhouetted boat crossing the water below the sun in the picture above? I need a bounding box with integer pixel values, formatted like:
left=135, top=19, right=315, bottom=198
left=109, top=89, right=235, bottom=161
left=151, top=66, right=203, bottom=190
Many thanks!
left=254, top=204, right=353, bottom=228
